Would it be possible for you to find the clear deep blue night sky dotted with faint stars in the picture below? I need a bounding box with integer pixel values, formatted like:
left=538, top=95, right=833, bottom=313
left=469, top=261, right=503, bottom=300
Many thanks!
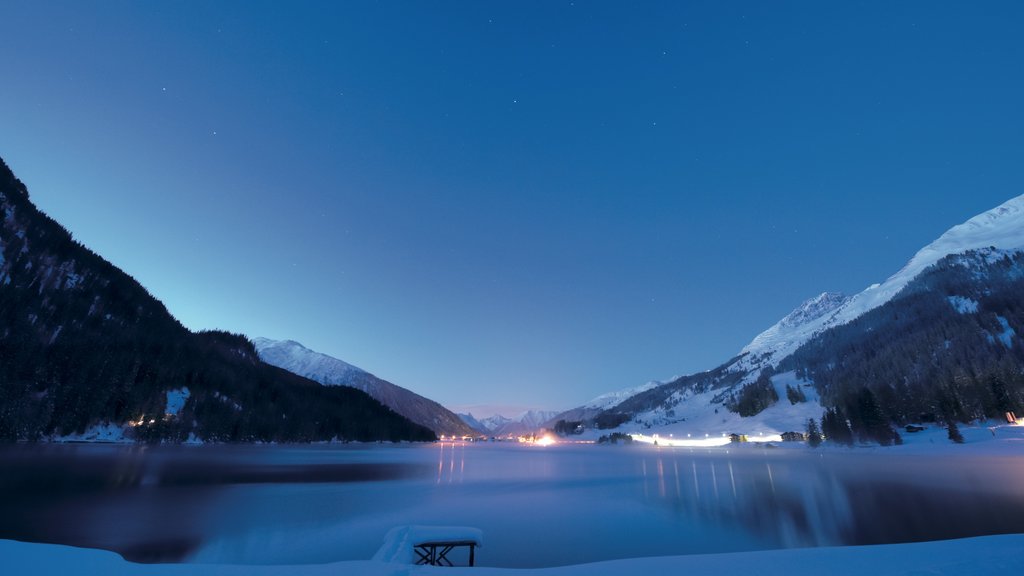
left=0, top=0, right=1024, bottom=415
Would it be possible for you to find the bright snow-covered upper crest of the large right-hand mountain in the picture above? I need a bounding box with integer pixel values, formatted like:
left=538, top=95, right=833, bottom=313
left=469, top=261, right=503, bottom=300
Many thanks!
left=733, top=195, right=1024, bottom=370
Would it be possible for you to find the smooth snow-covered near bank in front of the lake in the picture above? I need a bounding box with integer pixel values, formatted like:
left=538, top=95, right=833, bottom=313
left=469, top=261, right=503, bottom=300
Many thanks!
left=0, top=534, right=1024, bottom=576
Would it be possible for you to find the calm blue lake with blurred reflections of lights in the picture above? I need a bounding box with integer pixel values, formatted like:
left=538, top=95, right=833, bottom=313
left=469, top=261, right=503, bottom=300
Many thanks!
left=0, top=443, right=1024, bottom=568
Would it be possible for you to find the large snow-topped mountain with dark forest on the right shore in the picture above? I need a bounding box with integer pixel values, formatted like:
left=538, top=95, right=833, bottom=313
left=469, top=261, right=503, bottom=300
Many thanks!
left=558, top=196, right=1024, bottom=443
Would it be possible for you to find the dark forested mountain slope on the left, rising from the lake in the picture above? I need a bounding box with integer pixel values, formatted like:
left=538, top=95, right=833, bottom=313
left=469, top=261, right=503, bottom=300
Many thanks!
left=0, top=154, right=435, bottom=442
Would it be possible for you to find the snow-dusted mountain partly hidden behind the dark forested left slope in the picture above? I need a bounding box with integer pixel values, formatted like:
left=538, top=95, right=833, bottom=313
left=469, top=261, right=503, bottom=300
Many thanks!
left=252, top=337, right=477, bottom=437
